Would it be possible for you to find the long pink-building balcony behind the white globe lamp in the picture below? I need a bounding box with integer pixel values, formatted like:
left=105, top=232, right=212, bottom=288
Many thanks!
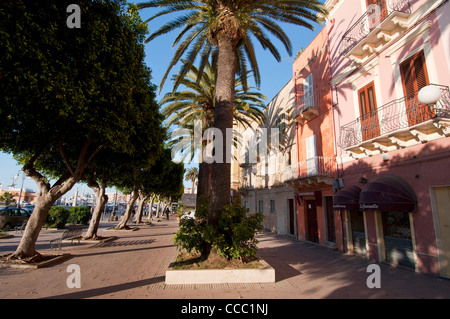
left=339, top=85, right=450, bottom=158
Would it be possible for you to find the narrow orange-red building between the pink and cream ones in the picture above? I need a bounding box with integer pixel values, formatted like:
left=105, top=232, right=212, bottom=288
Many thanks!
left=289, top=27, right=341, bottom=248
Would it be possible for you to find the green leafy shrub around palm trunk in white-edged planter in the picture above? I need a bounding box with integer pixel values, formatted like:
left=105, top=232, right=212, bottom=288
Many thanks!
left=174, top=198, right=263, bottom=259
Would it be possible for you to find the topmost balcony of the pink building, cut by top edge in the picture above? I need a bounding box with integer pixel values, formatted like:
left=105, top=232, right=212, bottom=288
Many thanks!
left=340, top=0, right=411, bottom=63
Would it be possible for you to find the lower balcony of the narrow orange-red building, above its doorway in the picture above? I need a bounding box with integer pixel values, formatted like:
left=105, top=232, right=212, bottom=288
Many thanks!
left=283, top=156, right=335, bottom=187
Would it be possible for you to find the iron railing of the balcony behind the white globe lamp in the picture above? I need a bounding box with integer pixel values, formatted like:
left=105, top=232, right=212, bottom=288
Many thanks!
left=339, top=85, right=450, bottom=149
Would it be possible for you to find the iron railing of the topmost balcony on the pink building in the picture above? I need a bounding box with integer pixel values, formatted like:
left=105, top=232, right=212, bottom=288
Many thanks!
left=340, top=0, right=411, bottom=55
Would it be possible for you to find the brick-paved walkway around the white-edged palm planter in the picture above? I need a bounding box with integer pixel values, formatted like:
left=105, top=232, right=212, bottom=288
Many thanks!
left=0, top=219, right=450, bottom=299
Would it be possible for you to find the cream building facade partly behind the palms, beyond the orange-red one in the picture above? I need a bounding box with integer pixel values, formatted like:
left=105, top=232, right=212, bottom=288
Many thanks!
left=240, top=79, right=298, bottom=236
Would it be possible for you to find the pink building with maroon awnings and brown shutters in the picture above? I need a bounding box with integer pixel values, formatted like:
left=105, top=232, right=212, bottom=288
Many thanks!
left=325, top=0, right=450, bottom=277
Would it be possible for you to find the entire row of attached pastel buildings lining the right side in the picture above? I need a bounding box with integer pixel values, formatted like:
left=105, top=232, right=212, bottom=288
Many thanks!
left=239, top=0, right=450, bottom=277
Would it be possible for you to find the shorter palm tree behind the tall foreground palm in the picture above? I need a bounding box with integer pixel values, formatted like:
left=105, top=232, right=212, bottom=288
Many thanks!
left=160, top=62, right=266, bottom=206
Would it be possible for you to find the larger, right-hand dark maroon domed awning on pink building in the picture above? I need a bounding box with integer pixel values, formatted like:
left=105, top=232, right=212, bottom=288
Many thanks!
left=359, top=175, right=417, bottom=212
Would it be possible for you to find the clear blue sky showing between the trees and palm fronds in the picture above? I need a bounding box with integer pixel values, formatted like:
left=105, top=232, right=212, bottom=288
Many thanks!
left=0, top=1, right=322, bottom=196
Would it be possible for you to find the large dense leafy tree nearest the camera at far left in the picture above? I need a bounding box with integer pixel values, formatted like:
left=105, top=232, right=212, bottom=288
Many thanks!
left=0, top=0, right=159, bottom=258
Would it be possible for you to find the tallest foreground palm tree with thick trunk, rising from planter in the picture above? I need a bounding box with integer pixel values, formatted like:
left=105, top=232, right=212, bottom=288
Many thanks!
left=138, top=0, right=325, bottom=225
